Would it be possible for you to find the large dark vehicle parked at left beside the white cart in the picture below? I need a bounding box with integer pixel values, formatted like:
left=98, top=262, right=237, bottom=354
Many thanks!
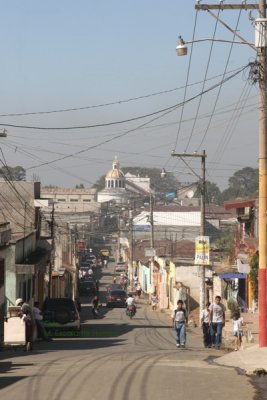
left=43, top=297, right=81, bottom=330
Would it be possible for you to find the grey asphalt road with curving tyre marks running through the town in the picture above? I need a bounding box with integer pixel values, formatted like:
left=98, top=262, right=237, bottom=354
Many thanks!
left=0, top=265, right=264, bottom=400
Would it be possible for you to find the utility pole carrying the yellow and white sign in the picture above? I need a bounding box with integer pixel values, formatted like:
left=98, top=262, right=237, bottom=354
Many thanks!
left=172, top=150, right=207, bottom=312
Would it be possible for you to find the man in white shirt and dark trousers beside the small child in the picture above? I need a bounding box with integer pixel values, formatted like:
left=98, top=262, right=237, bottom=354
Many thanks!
left=209, top=296, right=225, bottom=350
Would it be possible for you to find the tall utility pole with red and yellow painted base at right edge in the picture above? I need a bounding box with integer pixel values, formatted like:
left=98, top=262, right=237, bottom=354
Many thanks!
left=195, top=0, right=267, bottom=347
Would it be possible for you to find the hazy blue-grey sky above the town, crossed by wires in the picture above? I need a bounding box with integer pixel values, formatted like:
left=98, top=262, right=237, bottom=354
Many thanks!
left=0, top=0, right=258, bottom=188
